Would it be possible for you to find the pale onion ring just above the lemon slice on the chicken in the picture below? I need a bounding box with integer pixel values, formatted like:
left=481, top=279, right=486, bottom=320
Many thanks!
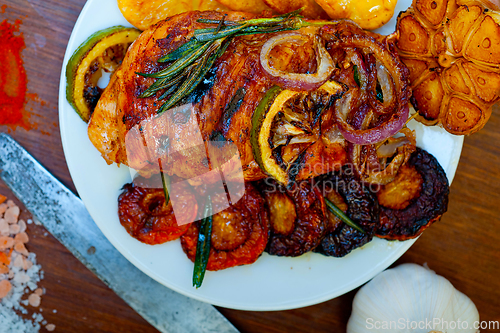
left=260, top=33, right=335, bottom=91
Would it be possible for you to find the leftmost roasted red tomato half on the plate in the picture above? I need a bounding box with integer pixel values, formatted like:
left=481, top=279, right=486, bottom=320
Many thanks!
left=118, top=176, right=198, bottom=245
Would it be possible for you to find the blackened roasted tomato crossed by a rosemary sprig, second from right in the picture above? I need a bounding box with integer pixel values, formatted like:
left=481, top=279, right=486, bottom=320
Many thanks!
left=316, top=167, right=379, bottom=257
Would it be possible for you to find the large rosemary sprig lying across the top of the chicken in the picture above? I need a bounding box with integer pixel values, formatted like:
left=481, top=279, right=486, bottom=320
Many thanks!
left=137, top=9, right=335, bottom=114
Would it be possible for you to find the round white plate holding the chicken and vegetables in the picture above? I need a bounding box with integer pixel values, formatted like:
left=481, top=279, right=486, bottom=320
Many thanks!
left=59, top=0, right=463, bottom=311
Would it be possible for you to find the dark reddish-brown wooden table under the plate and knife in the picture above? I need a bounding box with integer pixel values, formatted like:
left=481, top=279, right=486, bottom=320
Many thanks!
left=0, top=0, right=500, bottom=333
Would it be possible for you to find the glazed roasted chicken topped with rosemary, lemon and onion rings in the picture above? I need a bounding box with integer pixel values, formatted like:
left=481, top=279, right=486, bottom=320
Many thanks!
left=88, top=12, right=409, bottom=185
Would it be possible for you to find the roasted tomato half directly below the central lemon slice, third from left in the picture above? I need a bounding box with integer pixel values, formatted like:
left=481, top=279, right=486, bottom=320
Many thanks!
left=260, top=178, right=326, bottom=257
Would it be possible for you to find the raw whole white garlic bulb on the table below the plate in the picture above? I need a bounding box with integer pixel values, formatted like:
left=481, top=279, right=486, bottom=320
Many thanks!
left=347, top=264, right=479, bottom=333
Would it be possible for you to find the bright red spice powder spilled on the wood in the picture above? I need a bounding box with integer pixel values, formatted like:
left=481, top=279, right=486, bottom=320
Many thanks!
left=0, top=17, right=30, bottom=129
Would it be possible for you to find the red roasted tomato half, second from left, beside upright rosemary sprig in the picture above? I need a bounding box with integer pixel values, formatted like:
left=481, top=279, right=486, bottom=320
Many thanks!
left=181, top=183, right=269, bottom=271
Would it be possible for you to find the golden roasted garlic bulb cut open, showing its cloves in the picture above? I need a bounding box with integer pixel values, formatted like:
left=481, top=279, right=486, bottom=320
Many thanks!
left=396, top=0, right=500, bottom=135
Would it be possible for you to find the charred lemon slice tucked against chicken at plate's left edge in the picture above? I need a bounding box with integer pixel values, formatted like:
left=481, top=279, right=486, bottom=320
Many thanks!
left=66, top=26, right=141, bottom=122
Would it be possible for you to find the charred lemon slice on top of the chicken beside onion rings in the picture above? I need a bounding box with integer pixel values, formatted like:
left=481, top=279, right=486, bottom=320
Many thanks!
left=251, top=81, right=345, bottom=185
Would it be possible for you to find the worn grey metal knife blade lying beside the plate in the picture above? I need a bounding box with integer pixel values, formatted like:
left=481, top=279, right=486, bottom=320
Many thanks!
left=0, top=133, right=238, bottom=333
